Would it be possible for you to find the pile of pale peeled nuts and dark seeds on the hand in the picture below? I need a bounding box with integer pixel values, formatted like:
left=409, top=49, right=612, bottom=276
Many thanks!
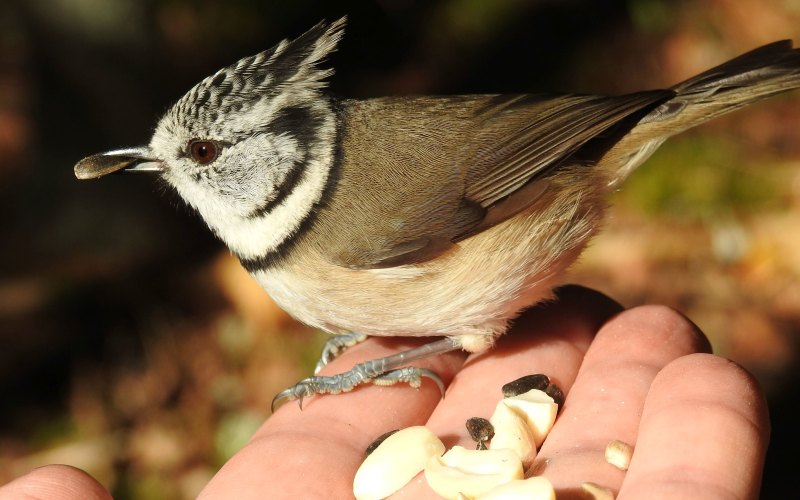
left=353, top=374, right=564, bottom=500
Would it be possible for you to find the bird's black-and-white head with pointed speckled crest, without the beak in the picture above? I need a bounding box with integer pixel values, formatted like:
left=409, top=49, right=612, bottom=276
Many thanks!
left=150, top=18, right=345, bottom=260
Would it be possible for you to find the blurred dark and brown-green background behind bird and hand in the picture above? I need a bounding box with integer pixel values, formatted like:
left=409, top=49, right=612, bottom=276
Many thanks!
left=0, top=0, right=800, bottom=499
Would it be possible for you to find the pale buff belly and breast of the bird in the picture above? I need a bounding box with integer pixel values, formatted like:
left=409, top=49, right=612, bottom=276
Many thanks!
left=254, top=193, right=602, bottom=352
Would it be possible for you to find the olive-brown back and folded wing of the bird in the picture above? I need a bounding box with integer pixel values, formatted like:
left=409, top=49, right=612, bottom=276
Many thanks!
left=326, top=90, right=674, bottom=269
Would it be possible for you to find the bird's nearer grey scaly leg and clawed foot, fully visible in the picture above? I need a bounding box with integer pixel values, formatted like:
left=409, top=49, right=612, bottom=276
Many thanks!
left=272, top=337, right=461, bottom=411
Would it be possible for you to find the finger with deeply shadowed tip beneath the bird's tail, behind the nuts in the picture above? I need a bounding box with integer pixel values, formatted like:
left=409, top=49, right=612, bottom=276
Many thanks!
left=392, top=286, right=621, bottom=499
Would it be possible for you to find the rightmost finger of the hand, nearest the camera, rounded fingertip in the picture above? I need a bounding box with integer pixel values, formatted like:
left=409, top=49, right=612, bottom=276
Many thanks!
left=619, top=354, right=769, bottom=499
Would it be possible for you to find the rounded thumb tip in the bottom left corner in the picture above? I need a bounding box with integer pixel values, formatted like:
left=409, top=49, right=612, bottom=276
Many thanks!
left=0, top=465, right=111, bottom=500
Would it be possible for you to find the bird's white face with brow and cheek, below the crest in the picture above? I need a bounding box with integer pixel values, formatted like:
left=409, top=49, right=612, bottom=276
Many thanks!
left=151, top=70, right=336, bottom=259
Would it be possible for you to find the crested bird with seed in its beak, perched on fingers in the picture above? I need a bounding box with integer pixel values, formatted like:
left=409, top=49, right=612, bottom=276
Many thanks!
left=74, top=18, right=800, bottom=410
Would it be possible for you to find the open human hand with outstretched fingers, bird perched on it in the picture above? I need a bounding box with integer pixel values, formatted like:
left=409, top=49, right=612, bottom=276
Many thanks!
left=0, top=286, right=769, bottom=500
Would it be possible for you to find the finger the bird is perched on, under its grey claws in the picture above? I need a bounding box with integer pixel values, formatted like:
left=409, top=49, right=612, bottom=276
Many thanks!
left=201, top=339, right=466, bottom=499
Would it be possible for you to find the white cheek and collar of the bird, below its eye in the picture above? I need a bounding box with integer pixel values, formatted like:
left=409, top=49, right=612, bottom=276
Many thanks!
left=159, top=115, right=335, bottom=259
